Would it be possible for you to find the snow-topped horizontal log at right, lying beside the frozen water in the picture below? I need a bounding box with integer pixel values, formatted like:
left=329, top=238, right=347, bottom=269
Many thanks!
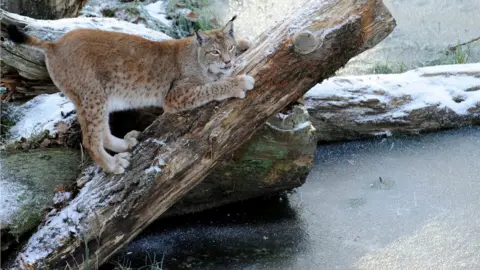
left=304, top=63, right=480, bottom=141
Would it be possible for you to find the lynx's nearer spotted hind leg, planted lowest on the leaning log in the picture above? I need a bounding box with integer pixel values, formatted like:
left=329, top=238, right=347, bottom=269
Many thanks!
left=77, top=102, right=130, bottom=174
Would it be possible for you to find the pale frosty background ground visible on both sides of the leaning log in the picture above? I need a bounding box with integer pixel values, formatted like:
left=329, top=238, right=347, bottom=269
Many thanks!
left=221, top=0, right=480, bottom=75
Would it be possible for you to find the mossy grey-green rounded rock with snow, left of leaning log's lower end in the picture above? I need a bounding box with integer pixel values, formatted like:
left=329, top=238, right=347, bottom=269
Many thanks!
left=0, top=148, right=81, bottom=252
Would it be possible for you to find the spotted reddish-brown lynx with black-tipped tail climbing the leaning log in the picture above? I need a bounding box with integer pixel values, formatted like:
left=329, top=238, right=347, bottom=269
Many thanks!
left=7, top=16, right=255, bottom=174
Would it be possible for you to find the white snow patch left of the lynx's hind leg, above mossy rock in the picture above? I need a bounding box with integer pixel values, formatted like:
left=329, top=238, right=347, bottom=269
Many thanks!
left=10, top=93, right=76, bottom=140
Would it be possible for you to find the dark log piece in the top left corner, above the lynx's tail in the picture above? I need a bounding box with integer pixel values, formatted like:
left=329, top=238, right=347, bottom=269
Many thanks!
left=0, top=0, right=87, bottom=20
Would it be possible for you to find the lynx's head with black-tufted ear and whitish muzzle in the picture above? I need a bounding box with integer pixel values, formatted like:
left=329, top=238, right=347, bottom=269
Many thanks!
left=195, top=15, right=237, bottom=76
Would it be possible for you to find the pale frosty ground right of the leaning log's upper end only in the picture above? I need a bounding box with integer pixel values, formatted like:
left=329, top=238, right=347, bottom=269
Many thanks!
left=338, top=0, right=480, bottom=75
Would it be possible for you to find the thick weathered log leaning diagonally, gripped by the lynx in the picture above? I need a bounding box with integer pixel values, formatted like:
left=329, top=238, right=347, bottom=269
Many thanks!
left=8, top=0, right=395, bottom=269
